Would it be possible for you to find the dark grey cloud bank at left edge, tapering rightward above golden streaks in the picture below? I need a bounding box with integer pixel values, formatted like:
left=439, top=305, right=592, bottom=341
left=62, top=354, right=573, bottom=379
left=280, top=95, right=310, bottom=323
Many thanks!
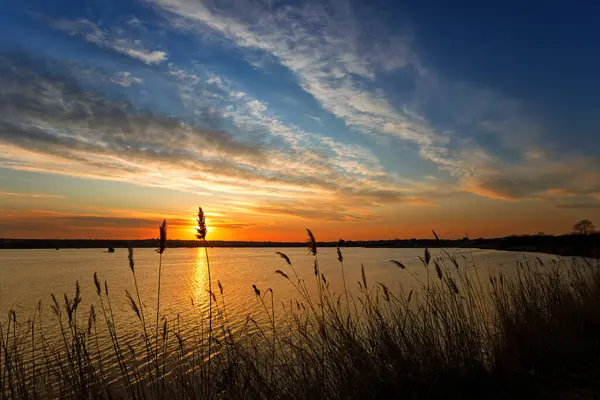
left=0, top=55, right=263, bottom=183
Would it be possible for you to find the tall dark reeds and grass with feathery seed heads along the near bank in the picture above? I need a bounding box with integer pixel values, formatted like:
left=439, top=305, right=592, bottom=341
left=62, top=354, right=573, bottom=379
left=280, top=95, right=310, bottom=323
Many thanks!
left=0, top=217, right=600, bottom=399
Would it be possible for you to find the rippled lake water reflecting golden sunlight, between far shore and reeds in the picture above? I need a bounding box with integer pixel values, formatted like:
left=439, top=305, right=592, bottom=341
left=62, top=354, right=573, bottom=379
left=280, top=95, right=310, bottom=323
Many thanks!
left=0, top=248, right=572, bottom=380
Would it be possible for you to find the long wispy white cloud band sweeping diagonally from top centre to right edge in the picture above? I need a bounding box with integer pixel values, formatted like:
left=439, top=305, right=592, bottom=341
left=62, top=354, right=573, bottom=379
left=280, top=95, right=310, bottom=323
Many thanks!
left=148, top=0, right=598, bottom=200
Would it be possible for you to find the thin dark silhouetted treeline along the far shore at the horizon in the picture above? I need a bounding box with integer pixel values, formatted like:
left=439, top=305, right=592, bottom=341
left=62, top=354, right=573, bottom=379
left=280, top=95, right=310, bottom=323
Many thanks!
left=0, top=233, right=600, bottom=258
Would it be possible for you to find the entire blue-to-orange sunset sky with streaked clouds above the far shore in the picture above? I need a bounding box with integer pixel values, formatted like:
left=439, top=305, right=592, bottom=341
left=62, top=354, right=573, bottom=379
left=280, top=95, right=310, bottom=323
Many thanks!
left=0, top=0, right=600, bottom=241
